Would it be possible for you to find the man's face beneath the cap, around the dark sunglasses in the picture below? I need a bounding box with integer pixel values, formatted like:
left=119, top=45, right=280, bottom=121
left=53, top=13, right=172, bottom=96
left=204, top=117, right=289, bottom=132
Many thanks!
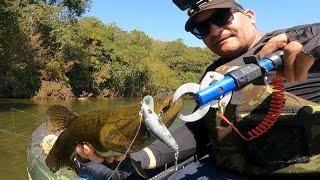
left=192, top=10, right=257, bottom=58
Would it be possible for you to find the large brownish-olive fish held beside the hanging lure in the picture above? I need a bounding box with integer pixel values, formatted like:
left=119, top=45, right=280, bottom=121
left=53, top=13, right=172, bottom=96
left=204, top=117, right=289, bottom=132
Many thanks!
left=45, top=93, right=183, bottom=172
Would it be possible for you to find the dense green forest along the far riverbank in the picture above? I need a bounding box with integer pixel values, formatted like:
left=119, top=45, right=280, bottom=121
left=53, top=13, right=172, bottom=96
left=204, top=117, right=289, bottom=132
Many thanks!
left=0, top=0, right=215, bottom=99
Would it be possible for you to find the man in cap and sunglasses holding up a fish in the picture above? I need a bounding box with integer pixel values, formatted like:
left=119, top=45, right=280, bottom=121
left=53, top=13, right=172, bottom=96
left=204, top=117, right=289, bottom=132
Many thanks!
left=76, top=0, right=320, bottom=179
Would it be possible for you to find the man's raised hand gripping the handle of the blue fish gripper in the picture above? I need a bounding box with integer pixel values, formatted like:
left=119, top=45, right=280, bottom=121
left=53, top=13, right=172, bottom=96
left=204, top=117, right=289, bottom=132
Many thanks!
left=258, top=33, right=315, bottom=82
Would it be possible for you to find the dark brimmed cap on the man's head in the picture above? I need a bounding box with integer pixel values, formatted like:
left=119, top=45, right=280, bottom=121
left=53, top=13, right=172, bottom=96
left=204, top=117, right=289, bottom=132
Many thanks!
left=185, top=0, right=244, bottom=32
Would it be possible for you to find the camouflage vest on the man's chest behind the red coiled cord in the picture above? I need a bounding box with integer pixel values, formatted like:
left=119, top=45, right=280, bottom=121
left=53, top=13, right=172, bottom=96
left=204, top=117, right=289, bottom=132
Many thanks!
left=202, top=34, right=320, bottom=175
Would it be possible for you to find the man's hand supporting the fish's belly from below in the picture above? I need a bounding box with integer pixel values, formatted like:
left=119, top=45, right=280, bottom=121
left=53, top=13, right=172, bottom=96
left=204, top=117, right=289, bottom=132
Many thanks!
left=76, top=143, right=126, bottom=163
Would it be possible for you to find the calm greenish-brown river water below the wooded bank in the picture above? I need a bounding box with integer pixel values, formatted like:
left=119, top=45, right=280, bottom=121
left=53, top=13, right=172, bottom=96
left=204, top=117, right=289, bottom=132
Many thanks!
left=0, top=98, right=195, bottom=180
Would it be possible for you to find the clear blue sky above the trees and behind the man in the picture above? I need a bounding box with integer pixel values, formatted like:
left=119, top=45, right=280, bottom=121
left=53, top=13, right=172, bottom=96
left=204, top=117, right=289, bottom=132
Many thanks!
left=85, top=0, right=320, bottom=47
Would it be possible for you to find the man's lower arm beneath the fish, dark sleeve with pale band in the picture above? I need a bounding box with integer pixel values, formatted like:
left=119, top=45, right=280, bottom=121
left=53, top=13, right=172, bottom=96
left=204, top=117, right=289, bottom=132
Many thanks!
left=76, top=125, right=196, bottom=169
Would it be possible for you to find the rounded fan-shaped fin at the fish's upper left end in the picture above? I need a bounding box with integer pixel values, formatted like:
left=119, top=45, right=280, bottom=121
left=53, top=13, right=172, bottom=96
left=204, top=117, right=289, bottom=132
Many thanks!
left=46, top=105, right=78, bottom=132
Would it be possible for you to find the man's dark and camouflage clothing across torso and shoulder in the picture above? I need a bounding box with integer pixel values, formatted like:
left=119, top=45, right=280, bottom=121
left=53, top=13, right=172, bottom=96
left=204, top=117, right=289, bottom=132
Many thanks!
left=187, top=24, right=320, bottom=174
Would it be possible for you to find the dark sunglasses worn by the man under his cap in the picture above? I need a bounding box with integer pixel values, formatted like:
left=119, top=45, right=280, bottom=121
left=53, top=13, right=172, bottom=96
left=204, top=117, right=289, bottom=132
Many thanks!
left=190, top=8, right=239, bottom=39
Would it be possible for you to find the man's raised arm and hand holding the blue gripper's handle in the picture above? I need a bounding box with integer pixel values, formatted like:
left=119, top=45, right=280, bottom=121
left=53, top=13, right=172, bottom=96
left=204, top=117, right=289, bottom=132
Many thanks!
left=258, top=23, right=320, bottom=82
